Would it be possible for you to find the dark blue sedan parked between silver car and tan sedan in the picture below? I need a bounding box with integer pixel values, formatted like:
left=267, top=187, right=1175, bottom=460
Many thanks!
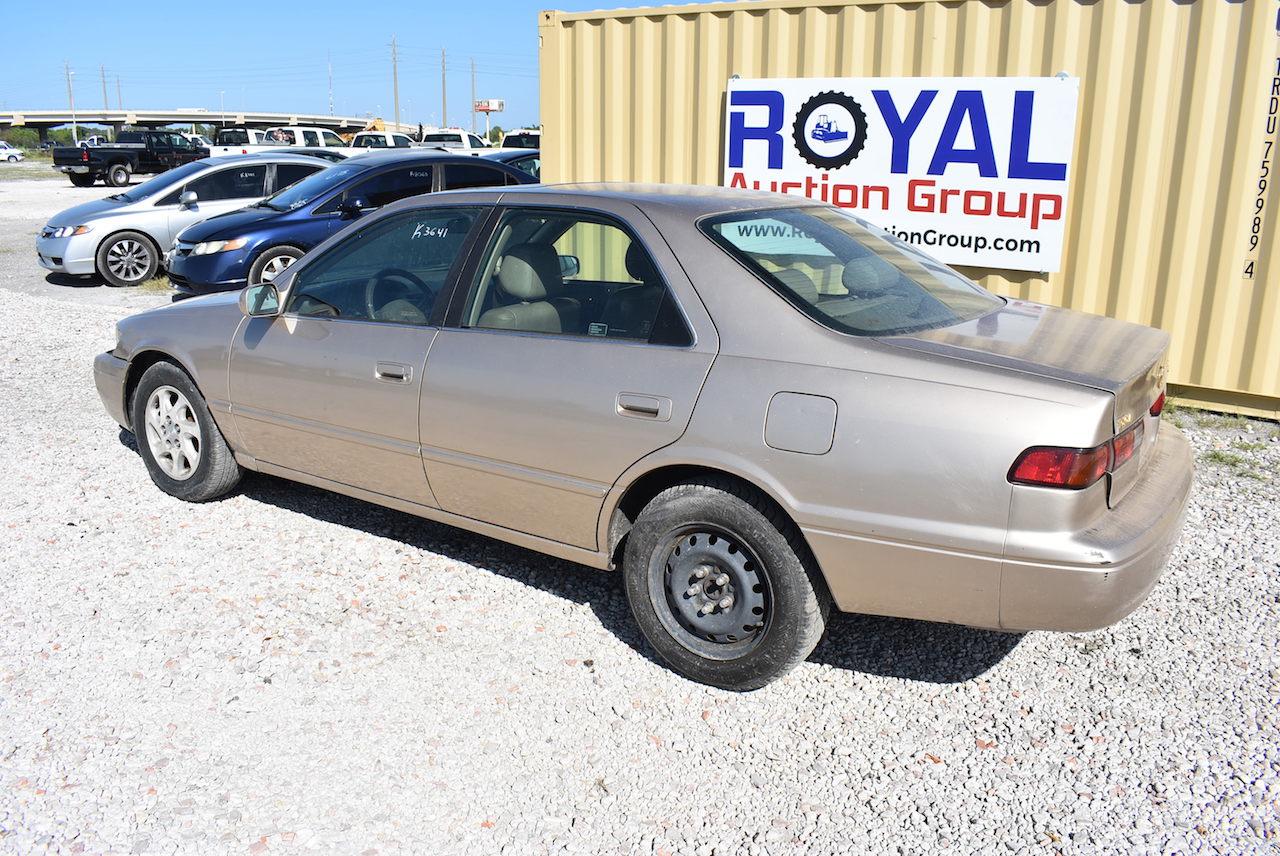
left=168, top=150, right=536, bottom=294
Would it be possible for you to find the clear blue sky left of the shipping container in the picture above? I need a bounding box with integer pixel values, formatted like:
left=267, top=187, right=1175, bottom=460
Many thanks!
left=0, top=0, right=616, bottom=128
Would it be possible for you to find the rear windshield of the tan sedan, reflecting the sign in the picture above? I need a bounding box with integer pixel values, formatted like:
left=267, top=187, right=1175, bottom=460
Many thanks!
left=701, top=206, right=1004, bottom=335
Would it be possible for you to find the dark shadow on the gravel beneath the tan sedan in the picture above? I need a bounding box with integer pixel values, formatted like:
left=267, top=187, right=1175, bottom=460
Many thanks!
left=120, top=430, right=1021, bottom=683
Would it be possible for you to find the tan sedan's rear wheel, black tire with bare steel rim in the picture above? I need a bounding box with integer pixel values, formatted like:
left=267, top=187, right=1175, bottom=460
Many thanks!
left=623, top=479, right=831, bottom=691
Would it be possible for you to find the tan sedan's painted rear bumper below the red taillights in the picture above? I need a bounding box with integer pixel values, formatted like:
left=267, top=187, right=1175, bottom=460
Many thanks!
left=801, top=424, right=1192, bottom=632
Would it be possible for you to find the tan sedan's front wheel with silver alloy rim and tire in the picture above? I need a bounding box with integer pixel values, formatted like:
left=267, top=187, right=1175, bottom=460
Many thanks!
left=129, top=362, right=243, bottom=503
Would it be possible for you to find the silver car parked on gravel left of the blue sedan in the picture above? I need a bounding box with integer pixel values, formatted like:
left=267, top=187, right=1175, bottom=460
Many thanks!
left=36, top=154, right=329, bottom=285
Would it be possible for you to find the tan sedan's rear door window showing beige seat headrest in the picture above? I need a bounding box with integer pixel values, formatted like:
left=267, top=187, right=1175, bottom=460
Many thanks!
left=462, top=209, right=691, bottom=345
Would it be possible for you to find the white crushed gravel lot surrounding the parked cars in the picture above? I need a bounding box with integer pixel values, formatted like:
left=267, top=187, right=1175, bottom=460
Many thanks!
left=0, top=176, right=1280, bottom=856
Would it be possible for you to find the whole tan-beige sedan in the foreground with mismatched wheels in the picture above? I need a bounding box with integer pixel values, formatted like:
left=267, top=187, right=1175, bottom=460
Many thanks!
left=95, top=184, right=1192, bottom=690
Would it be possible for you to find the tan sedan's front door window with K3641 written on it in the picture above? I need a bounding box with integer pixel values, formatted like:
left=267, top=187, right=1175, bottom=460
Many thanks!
left=287, top=207, right=481, bottom=325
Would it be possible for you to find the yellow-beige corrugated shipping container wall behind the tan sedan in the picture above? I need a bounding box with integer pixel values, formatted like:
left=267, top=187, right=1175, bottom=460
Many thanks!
left=539, top=0, right=1280, bottom=416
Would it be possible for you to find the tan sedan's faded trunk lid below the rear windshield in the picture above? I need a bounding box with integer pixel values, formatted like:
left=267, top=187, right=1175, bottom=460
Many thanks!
left=882, top=301, right=1169, bottom=430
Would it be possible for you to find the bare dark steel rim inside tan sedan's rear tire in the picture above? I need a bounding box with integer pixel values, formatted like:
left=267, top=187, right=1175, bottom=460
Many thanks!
left=649, top=523, right=771, bottom=660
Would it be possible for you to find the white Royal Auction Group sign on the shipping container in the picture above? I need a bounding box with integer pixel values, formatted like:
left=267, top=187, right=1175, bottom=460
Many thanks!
left=724, top=77, right=1080, bottom=271
